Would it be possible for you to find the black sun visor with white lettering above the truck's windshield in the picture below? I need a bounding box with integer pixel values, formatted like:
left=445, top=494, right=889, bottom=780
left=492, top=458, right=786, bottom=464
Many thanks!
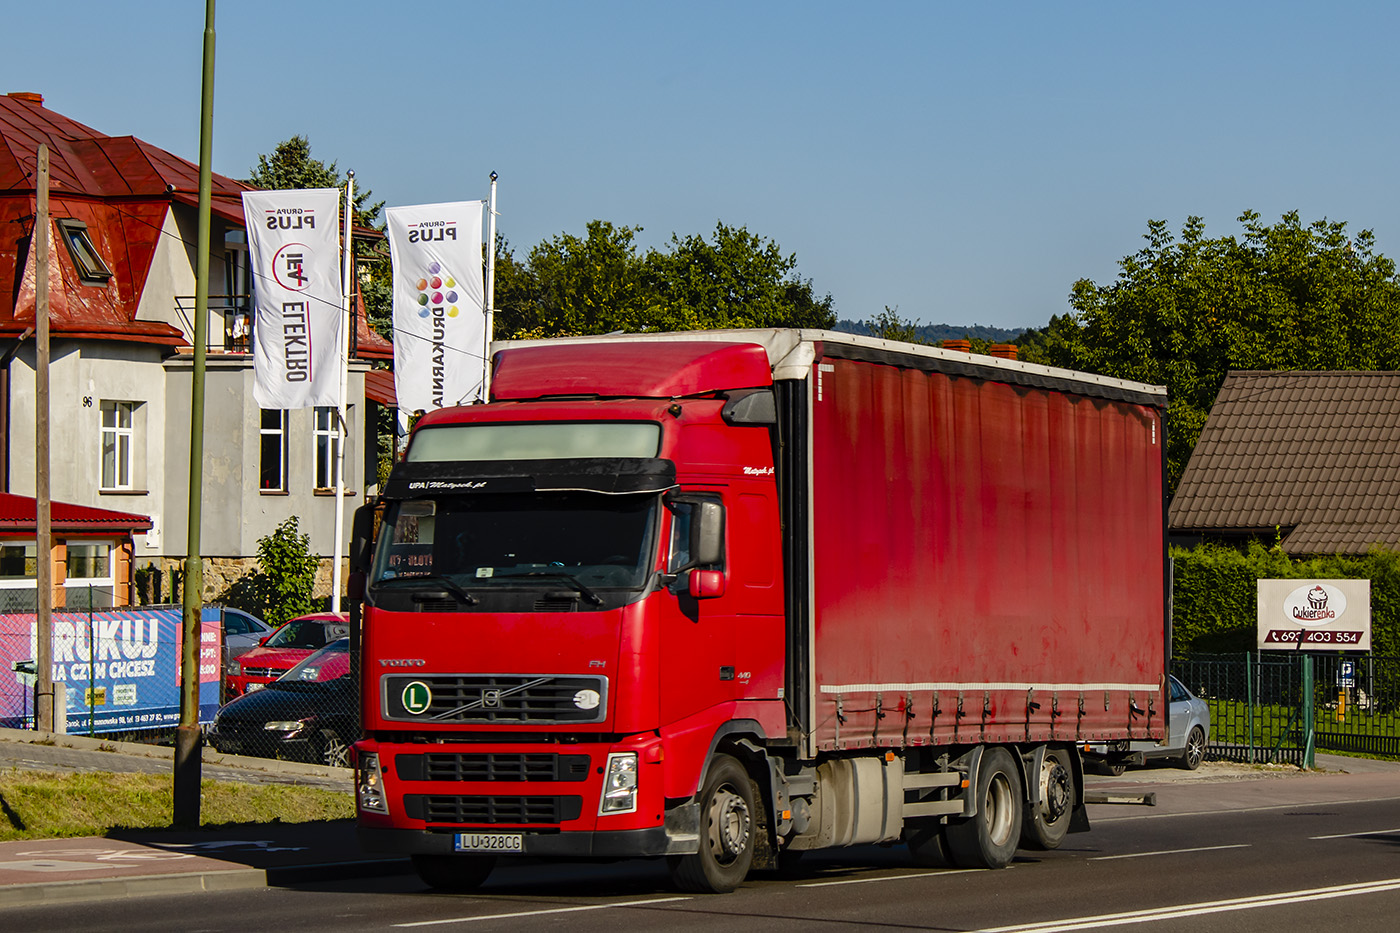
left=384, top=458, right=676, bottom=499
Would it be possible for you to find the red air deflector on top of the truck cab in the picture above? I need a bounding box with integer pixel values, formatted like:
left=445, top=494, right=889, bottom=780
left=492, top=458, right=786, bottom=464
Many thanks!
left=491, top=340, right=773, bottom=401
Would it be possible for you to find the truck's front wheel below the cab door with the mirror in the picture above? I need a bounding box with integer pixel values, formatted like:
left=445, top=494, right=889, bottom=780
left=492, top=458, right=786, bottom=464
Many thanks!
left=666, top=755, right=759, bottom=894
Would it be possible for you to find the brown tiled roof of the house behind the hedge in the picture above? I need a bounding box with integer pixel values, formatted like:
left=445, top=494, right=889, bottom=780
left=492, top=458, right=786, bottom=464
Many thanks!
left=1169, top=371, right=1400, bottom=555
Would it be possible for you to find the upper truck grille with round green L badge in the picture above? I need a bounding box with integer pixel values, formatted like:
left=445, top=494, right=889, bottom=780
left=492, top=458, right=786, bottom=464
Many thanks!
left=381, top=674, right=608, bottom=723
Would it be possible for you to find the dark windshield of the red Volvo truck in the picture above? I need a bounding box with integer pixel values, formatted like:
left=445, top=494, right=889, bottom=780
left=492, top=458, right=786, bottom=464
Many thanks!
left=371, top=492, right=657, bottom=590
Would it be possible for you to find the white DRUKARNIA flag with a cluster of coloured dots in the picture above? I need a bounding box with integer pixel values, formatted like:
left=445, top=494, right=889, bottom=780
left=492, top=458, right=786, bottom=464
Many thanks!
left=385, top=200, right=486, bottom=412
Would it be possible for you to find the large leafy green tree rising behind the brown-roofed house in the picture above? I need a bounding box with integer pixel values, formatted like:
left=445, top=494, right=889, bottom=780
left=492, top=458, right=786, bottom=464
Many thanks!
left=1019, top=212, right=1400, bottom=492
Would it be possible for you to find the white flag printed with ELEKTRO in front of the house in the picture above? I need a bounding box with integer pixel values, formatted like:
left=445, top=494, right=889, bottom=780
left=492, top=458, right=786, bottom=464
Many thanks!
left=244, top=188, right=344, bottom=408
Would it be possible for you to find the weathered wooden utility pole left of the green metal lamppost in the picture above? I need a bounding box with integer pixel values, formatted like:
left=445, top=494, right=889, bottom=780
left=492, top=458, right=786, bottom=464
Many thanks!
left=34, top=143, right=52, bottom=733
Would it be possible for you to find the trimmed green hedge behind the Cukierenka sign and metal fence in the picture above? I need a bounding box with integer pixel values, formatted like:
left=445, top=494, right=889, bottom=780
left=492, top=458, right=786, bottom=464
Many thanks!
left=1172, top=542, right=1400, bottom=658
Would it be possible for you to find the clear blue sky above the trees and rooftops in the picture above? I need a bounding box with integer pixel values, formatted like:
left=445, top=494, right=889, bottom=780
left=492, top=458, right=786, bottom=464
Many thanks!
left=10, top=0, right=1400, bottom=328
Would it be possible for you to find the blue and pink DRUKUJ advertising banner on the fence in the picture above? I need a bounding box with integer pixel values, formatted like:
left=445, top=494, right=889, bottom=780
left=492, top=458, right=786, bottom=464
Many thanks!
left=0, top=607, right=223, bottom=733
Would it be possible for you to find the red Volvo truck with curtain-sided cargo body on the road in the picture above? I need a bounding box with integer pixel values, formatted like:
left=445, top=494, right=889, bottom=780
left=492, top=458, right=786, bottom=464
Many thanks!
left=351, top=331, right=1169, bottom=892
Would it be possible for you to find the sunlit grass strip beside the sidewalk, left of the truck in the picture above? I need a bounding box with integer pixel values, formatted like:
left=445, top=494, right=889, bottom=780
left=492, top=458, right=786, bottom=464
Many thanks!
left=0, top=769, right=354, bottom=842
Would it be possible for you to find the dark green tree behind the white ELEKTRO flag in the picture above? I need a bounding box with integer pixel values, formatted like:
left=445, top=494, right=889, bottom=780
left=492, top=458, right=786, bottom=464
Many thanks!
left=248, top=136, right=393, bottom=339
